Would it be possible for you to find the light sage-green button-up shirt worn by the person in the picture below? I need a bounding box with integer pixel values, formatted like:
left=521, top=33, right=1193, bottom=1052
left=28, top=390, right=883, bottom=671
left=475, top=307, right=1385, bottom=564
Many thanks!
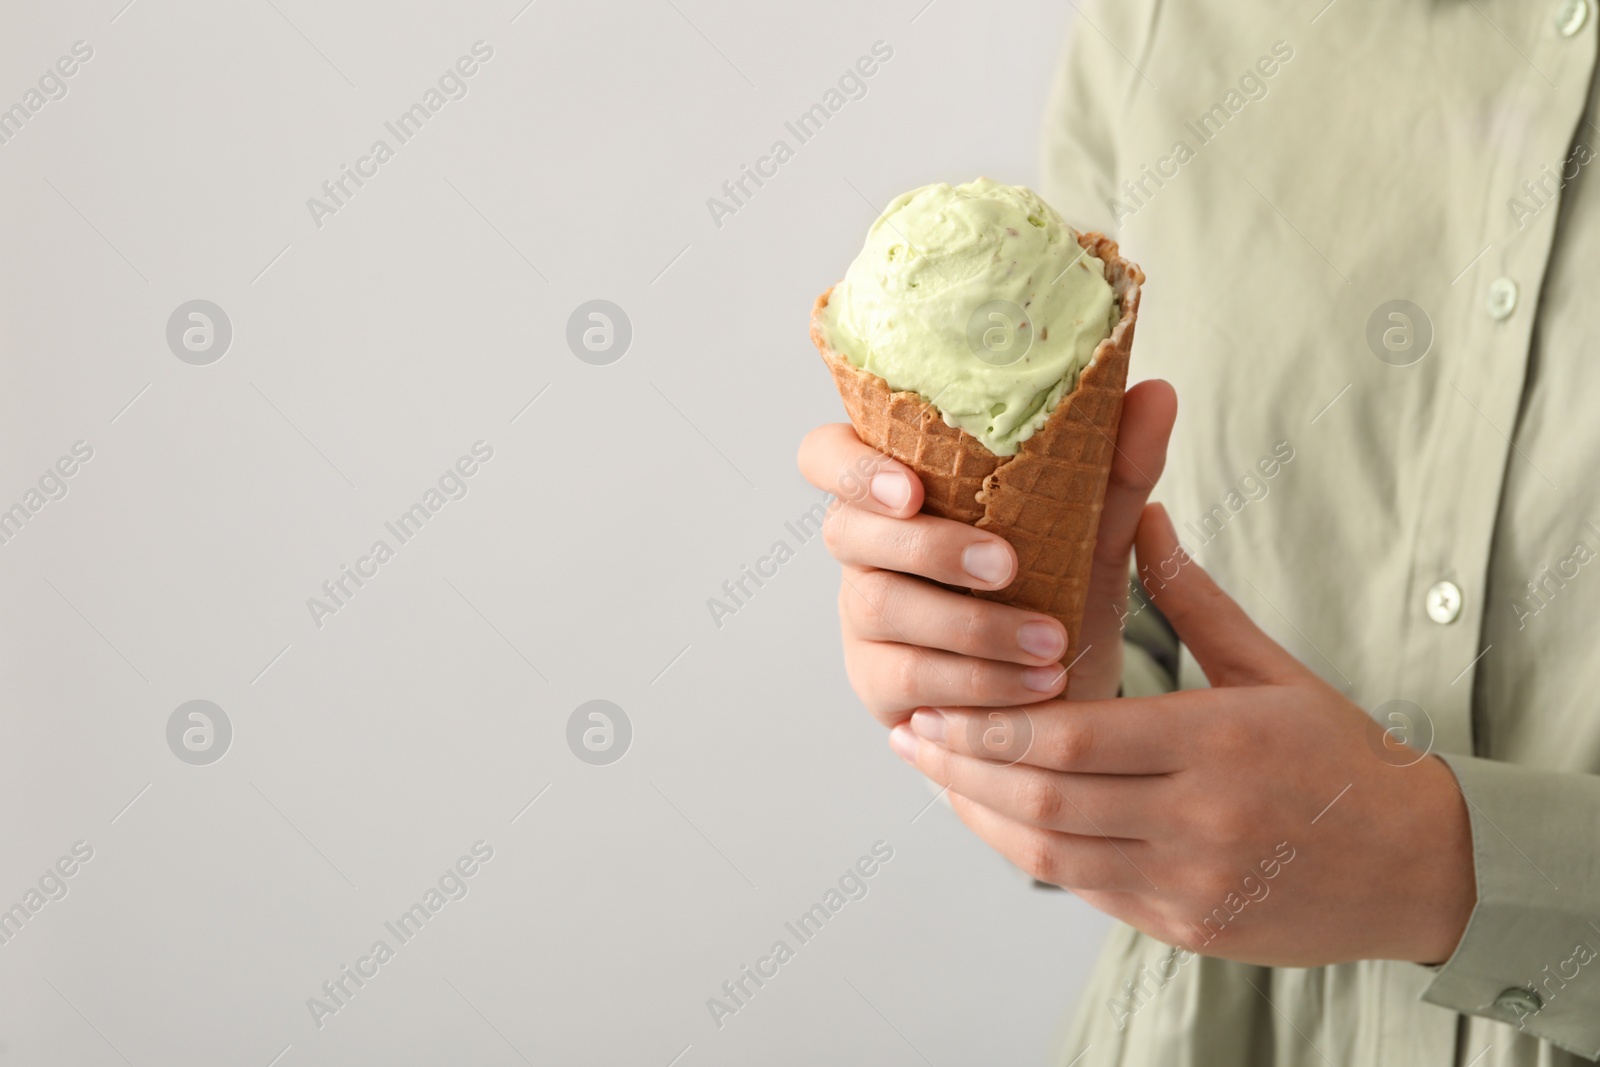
left=1040, top=0, right=1600, bottom=1067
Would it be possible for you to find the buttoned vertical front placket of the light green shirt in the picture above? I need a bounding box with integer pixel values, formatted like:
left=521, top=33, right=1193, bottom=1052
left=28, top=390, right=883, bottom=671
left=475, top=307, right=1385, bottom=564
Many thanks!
left=1402, top=0, right=1595, bottom=767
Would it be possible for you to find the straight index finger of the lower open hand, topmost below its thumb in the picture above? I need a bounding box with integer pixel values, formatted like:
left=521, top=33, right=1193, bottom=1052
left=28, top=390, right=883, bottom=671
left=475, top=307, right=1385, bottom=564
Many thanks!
left=910, top=701, right=1198, bottom=776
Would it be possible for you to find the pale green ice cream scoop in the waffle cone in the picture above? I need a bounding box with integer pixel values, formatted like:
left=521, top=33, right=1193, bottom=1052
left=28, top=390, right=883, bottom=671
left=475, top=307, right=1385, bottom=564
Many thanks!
left=822, top=178, right=1118, bottom=456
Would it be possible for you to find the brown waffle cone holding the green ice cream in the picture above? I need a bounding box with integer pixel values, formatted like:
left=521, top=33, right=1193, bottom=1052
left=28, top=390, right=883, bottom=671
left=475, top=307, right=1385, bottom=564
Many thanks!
left=811, top=234, right=1144, bottom=665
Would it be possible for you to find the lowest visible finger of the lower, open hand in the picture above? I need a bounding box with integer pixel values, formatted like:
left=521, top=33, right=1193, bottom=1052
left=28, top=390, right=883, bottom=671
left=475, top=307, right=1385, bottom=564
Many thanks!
left=950, top=790, right=1150, bottom=893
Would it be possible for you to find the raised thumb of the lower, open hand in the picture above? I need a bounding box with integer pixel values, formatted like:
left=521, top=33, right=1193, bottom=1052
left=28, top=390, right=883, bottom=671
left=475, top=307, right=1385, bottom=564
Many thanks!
left=1134, top=504, right=1304, bottom=686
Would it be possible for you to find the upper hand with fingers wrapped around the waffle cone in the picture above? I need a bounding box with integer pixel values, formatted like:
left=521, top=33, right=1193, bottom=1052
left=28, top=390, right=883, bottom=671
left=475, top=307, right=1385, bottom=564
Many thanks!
left=798, top=381, right=1178, bottom=726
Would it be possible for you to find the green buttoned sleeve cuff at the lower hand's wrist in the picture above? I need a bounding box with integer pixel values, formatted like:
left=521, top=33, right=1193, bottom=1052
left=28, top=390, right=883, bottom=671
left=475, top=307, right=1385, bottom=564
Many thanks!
left=1422, top=755, right=1600, bottom=1059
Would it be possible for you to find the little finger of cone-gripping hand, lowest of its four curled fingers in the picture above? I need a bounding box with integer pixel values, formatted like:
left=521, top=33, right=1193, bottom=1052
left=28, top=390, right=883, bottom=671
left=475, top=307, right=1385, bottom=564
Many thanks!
left=845, top=620, right=1066, bottom=723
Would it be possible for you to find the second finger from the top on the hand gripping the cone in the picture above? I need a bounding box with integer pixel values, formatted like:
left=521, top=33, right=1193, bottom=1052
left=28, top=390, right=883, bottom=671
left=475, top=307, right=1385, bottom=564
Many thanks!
left=822, top=506, right=1016, bottom=589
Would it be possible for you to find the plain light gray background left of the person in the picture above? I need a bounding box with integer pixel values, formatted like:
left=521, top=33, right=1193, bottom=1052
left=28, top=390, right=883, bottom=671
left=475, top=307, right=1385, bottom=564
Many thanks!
left=0, top=0, right=1104, bottom=1067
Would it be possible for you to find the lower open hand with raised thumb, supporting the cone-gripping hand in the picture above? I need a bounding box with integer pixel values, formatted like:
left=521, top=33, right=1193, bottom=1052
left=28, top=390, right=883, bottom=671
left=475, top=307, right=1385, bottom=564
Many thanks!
left=890, top=506, right=1477, bottom=966
